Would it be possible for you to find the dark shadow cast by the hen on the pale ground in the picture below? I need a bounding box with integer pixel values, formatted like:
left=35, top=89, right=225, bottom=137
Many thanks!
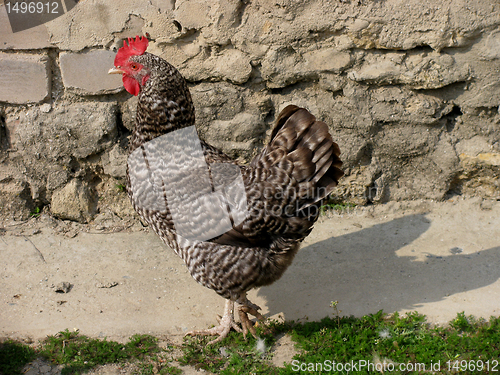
left=258, top=215, right=500, bottom=320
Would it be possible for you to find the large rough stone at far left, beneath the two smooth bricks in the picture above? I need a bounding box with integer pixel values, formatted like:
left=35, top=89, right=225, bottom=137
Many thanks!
left=0, top=103, right=117, bottom=213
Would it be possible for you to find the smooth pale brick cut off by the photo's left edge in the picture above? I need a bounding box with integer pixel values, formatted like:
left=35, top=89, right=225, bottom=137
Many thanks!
left=0, top=53, right=50, bottom=104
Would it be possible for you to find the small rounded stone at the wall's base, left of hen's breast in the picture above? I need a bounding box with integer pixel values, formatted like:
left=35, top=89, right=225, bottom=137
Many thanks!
left=50, top=179, right=96, bottom=223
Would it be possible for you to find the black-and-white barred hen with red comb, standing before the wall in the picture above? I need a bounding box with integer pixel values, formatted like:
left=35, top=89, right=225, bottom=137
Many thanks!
left=109, top=36, right=343, bottom=343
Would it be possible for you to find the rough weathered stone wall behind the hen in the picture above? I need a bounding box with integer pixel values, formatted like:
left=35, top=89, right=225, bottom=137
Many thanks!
left=0, top=0, right=500, bottom=222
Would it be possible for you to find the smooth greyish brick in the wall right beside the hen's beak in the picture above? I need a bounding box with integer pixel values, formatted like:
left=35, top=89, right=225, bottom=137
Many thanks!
left=59, top=50, right=123, bottom=94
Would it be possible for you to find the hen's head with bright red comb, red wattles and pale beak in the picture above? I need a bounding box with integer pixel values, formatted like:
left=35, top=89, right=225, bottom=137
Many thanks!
left=108, top=36, right=150, bottom=95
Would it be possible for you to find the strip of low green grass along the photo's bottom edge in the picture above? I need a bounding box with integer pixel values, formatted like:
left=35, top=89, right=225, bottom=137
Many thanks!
left=0, top=312, right=500, bottom=375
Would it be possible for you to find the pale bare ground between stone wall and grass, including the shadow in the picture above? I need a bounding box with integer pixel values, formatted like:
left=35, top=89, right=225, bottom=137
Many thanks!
left=0, top=198, right=500, bottom=350
